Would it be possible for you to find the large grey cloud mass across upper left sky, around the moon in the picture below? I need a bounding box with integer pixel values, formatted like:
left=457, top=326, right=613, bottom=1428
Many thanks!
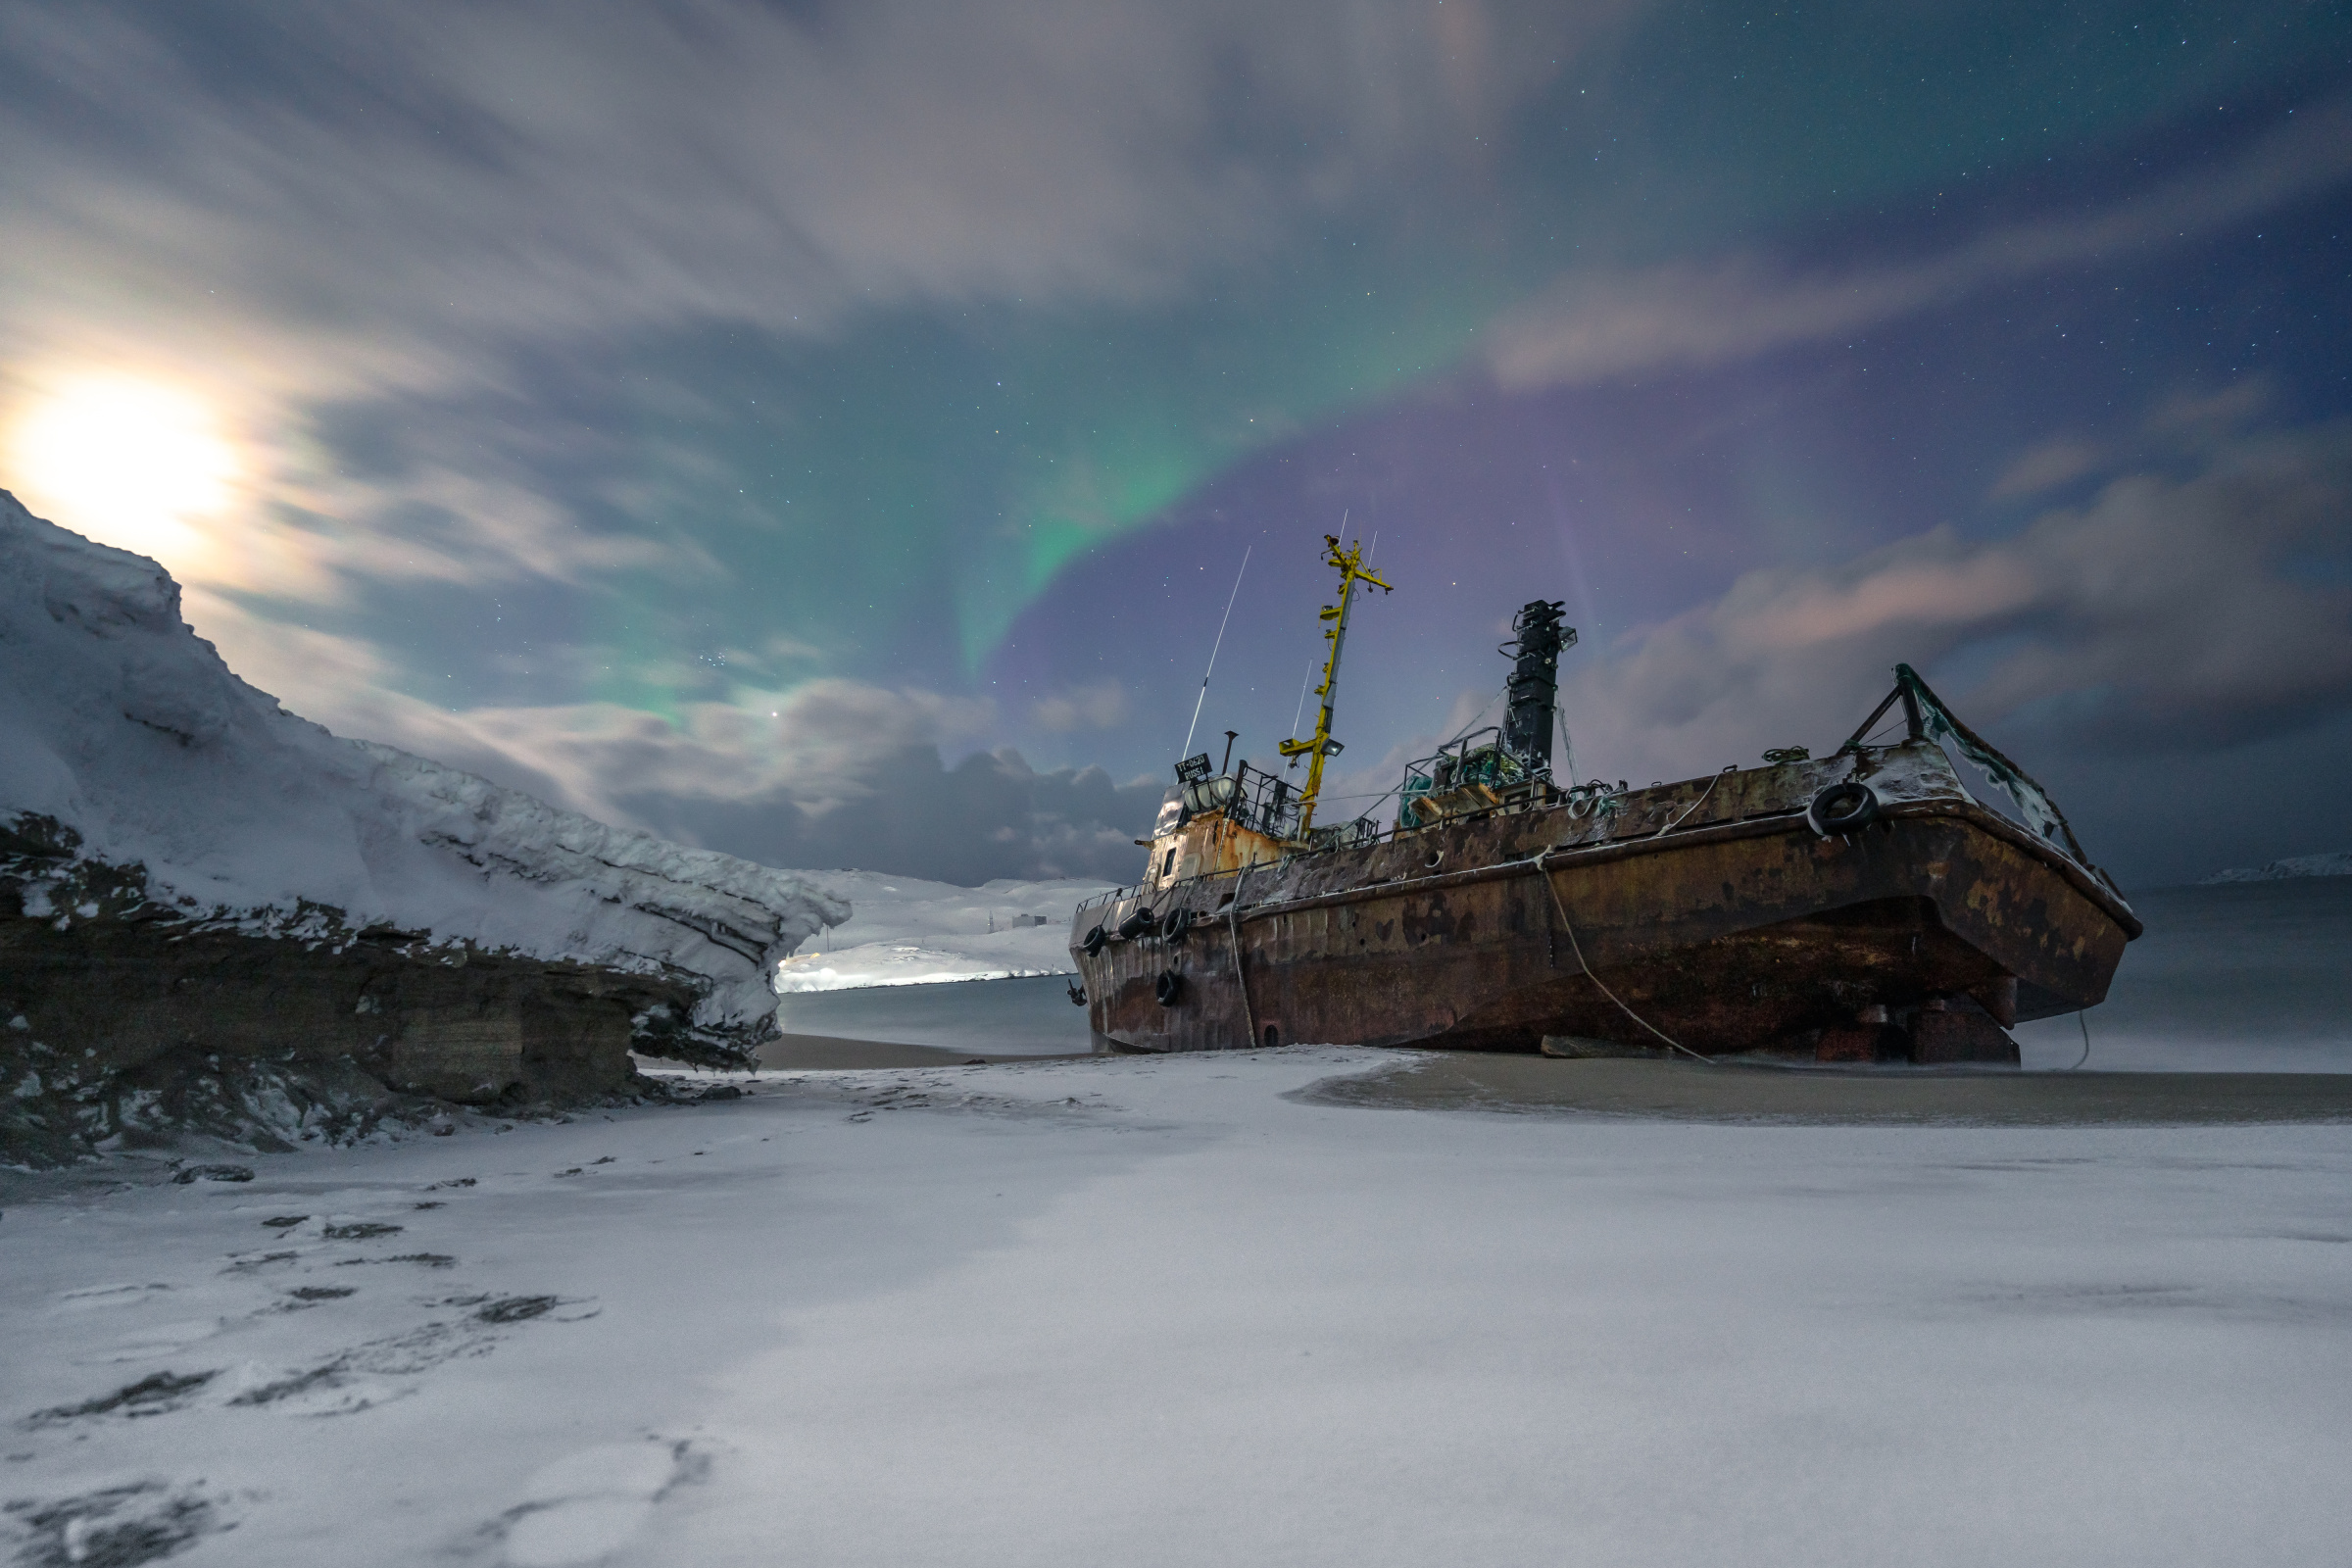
left=0, top=0, right=1633, bottom=667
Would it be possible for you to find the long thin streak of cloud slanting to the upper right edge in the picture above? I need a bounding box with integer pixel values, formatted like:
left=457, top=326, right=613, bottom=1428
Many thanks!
left=1487, top=101, right=2352, bottom=390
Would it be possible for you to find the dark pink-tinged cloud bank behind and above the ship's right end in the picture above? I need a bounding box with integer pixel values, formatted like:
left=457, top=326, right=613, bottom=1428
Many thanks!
left=1562, top=411, right=2352, bottom=778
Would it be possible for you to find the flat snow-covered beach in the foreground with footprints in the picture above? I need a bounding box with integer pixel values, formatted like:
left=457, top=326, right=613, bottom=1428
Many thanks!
left=0, top=1048, right=2352, bottom=1568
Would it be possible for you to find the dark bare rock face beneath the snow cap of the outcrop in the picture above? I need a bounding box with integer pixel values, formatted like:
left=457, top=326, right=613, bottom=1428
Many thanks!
left=0, top=818, right=733, bottom=1166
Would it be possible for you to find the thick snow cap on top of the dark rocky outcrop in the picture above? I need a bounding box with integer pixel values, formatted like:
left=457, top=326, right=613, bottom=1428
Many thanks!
left=0, top=491, right=849, bottom=1027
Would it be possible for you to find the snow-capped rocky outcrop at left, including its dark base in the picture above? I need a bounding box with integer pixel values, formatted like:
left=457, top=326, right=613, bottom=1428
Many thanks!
left=0, top=491, right=849, bottom=1163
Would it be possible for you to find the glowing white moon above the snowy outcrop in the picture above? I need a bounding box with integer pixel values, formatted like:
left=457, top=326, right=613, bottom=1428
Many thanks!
left=7, top=376, right=245, bottom=578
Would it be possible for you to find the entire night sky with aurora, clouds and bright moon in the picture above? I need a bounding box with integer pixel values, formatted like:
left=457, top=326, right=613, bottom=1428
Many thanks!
left=0, top=0, right=2352, bottom=886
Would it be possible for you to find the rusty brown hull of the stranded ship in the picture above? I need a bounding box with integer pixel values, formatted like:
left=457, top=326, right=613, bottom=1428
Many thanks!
left=1070, top=738, right=2140, bottom=1062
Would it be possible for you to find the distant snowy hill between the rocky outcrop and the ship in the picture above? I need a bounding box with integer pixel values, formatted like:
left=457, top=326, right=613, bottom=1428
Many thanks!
left=776, top=872, right=1110, bottom=995
